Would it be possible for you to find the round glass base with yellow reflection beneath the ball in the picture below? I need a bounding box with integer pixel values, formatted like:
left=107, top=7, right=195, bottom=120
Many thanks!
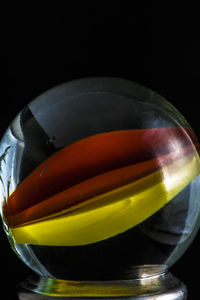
left=18, top=272, right=187, bottom=300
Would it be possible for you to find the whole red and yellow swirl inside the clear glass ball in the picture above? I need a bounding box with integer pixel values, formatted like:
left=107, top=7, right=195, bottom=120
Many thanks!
left=3, top=127, right=200, bottom=246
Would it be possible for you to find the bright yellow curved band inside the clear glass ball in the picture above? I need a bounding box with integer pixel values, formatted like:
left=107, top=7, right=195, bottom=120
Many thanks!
left=10, top=152, right=200, bottom=246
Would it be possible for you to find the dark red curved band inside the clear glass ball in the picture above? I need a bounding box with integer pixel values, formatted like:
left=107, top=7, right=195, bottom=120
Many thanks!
left=4, top=127, right=197, bottom=226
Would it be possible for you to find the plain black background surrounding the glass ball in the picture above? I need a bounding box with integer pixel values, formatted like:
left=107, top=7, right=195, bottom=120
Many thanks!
left=3, top=1, right=200, bottom=300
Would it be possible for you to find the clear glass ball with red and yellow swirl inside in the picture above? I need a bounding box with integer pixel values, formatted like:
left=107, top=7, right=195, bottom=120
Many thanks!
left=0, top=77, right=200, bottom=280
